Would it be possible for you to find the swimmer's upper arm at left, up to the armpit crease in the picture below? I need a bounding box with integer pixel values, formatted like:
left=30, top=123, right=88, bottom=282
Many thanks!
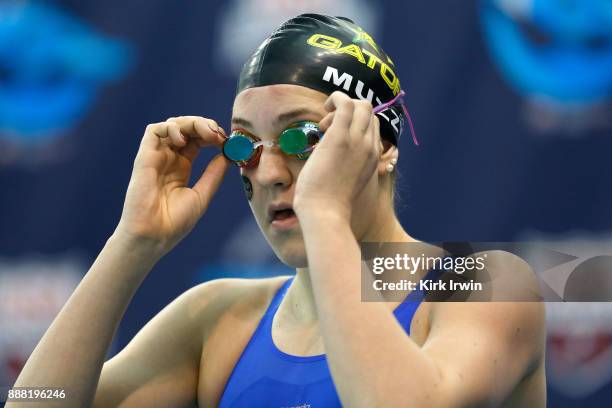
left=94, top=282, right=221, bottom=407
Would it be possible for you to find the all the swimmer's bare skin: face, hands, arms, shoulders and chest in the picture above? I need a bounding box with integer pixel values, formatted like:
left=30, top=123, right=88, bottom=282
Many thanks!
left=7, top=85, right=545, bottom=407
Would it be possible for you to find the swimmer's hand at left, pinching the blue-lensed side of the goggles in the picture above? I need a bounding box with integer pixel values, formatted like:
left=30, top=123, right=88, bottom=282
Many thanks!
left=114, top=116, right=230, bottom=256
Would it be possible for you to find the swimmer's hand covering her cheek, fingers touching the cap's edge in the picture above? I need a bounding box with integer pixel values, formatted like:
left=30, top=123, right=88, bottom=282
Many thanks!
left=293, top=91, right=382, bottom=221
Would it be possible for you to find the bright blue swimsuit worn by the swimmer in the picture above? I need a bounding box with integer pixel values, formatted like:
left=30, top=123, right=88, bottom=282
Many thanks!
left=219, top=271, right=437, bottom=408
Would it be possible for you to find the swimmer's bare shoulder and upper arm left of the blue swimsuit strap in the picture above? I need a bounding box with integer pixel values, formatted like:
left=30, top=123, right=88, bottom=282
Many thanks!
left=94, top=277, right=287, bottom=407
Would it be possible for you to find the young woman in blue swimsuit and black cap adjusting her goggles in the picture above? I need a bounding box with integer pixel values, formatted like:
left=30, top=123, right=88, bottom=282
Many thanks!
left=7, top=14, right=545, bottom=407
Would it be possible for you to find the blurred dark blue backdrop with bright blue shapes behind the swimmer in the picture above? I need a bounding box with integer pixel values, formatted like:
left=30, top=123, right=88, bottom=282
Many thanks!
left=0, top=0, right=612, bottom=407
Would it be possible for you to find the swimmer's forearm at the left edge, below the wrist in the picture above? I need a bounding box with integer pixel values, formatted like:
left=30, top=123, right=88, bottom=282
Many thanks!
left=7, top=231, right=159, bottom=407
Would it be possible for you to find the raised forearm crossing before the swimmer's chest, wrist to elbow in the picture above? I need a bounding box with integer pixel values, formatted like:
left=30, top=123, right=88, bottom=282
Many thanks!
left=300, top=216, right=441, bottom=407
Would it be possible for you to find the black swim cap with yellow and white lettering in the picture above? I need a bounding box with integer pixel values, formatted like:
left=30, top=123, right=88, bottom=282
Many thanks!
left=236, top=14, right=416, bottom=145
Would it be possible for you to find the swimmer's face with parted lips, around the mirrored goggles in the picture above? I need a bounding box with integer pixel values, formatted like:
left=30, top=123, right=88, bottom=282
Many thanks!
left=232, top=85, right=389, bottom=268
